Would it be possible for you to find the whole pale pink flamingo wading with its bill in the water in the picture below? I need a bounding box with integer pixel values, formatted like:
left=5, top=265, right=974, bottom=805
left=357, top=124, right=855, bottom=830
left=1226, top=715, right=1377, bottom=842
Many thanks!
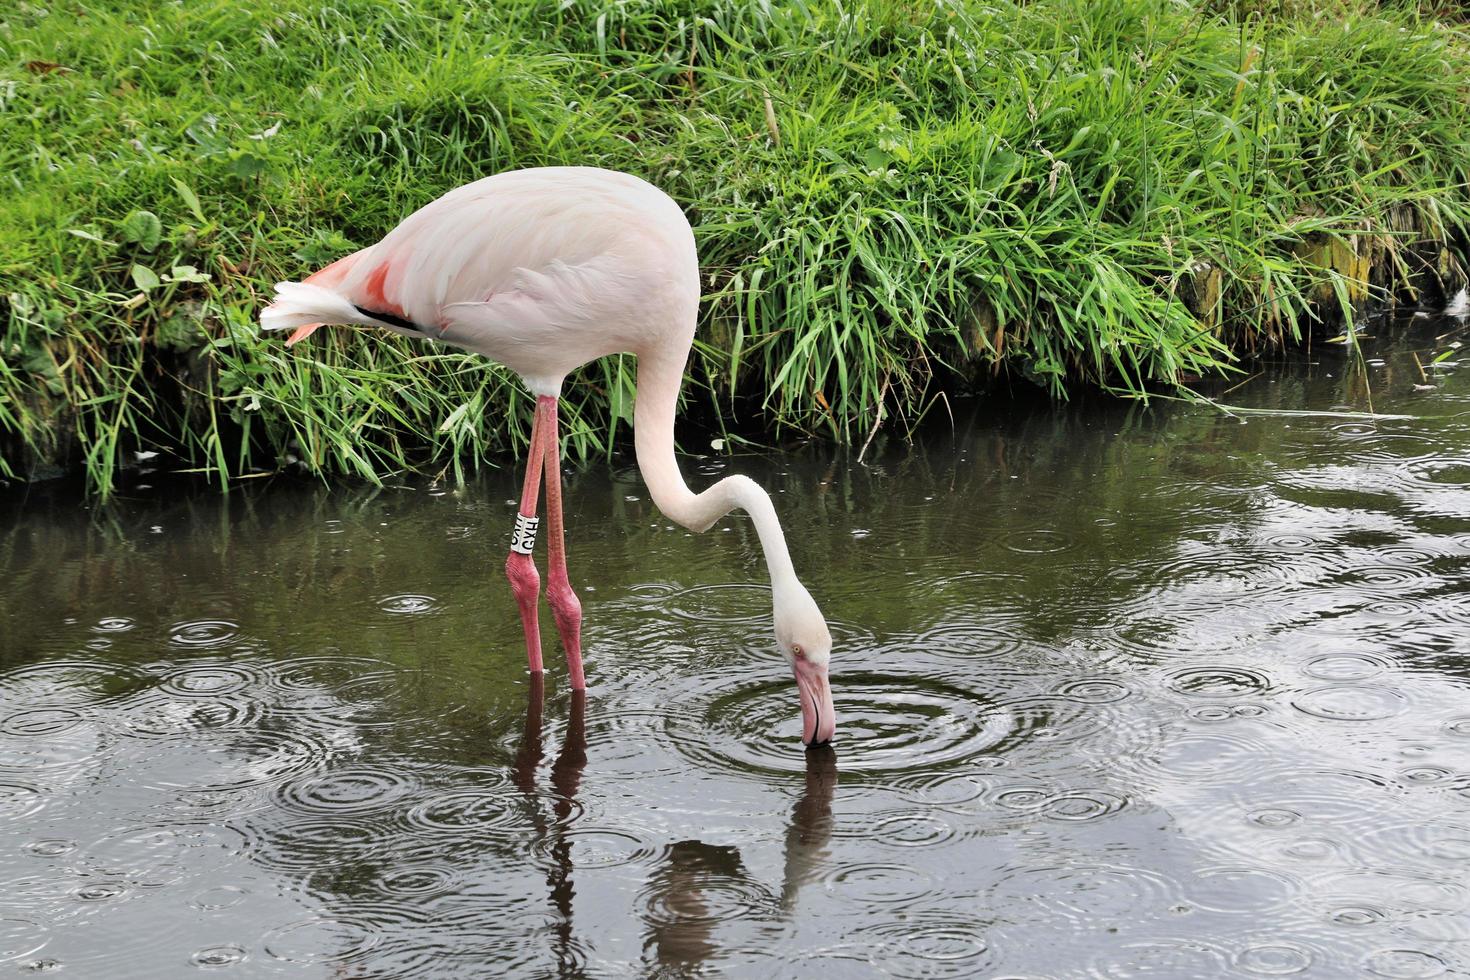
left=260, top=167, right=836, bottom=746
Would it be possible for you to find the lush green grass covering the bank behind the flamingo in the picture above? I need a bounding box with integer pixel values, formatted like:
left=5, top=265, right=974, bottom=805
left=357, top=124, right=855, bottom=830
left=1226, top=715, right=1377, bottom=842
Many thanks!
left=0, top=0, right=1470, bottom=492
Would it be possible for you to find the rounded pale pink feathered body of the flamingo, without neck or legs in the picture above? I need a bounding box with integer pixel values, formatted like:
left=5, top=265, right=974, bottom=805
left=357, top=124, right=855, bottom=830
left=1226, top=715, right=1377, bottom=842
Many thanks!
left=271, top=167, right=700, bottom=395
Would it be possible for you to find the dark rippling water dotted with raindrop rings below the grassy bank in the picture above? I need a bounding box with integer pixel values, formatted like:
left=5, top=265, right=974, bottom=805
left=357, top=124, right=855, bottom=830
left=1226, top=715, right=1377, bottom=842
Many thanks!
left=0, top=323, right=1470, bottom=979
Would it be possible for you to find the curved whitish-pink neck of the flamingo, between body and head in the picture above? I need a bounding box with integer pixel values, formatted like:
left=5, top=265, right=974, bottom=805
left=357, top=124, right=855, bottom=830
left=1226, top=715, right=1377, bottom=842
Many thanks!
left=634, top=353, right=801, bottom=589
